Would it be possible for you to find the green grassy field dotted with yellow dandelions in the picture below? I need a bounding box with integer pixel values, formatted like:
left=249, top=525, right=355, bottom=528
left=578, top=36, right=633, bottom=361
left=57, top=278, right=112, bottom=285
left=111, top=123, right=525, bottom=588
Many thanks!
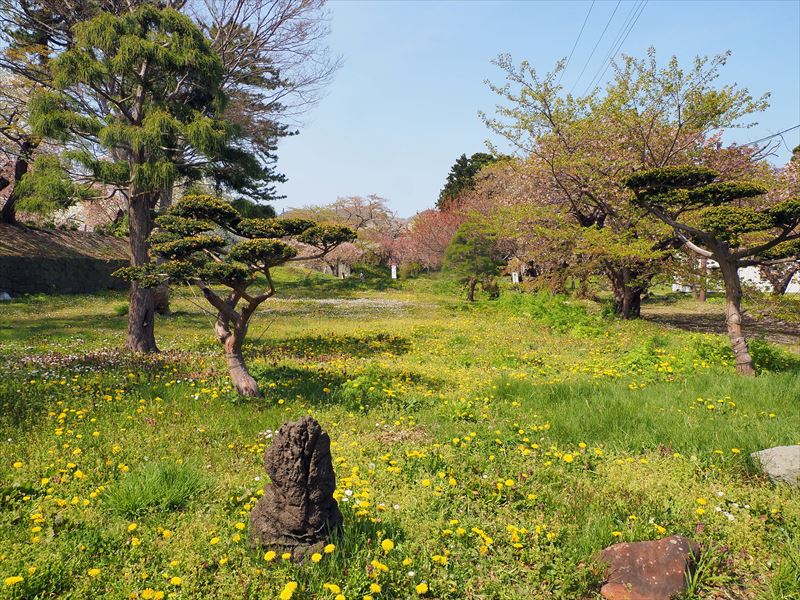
left=0, top=270, right=800, bottom=600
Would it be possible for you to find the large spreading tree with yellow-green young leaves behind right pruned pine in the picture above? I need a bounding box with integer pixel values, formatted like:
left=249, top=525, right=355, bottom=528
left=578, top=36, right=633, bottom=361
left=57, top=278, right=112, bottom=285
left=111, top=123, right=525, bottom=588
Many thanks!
left=484, top=51, right=766, bottom=318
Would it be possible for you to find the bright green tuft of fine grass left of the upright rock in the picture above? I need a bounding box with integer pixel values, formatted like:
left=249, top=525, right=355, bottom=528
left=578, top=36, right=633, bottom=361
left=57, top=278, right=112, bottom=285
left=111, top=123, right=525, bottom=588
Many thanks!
left=105, top=462, right=208, bottom=517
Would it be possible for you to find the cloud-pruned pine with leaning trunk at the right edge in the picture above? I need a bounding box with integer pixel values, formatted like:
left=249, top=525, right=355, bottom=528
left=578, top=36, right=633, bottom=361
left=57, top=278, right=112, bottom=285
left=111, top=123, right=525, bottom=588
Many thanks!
left=626, top=166, right=800, bottom=375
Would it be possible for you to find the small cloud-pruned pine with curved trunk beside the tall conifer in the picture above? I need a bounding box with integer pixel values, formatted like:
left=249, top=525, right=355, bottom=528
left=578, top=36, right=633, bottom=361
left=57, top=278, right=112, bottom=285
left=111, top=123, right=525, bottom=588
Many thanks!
left=117, top=196, right=355, bottom=396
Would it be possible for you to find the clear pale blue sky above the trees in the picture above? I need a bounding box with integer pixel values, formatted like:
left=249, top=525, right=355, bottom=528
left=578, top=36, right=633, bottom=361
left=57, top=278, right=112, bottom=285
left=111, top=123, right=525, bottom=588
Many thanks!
left=276, top=0, right=800, bottom=216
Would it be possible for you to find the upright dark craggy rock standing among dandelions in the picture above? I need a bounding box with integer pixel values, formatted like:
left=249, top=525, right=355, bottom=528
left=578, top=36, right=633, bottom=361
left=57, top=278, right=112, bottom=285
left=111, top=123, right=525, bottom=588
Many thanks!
left=250, top=417, right=342, bottom=558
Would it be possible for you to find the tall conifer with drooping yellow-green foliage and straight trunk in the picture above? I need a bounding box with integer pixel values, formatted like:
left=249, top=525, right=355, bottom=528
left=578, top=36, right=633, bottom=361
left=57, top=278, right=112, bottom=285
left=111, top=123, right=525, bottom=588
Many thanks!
left=30, top=4, right=232, bottom=352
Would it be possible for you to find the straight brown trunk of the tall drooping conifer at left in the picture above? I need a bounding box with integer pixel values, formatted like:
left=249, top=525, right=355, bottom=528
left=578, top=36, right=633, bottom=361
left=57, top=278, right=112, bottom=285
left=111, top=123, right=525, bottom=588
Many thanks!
left=125, top=187, right=158, bottom=352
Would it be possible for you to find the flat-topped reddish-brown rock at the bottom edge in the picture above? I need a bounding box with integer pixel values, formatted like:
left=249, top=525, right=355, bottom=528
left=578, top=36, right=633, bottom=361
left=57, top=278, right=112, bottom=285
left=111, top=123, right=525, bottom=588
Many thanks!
left=599, top=535, right=700, bottom=600
